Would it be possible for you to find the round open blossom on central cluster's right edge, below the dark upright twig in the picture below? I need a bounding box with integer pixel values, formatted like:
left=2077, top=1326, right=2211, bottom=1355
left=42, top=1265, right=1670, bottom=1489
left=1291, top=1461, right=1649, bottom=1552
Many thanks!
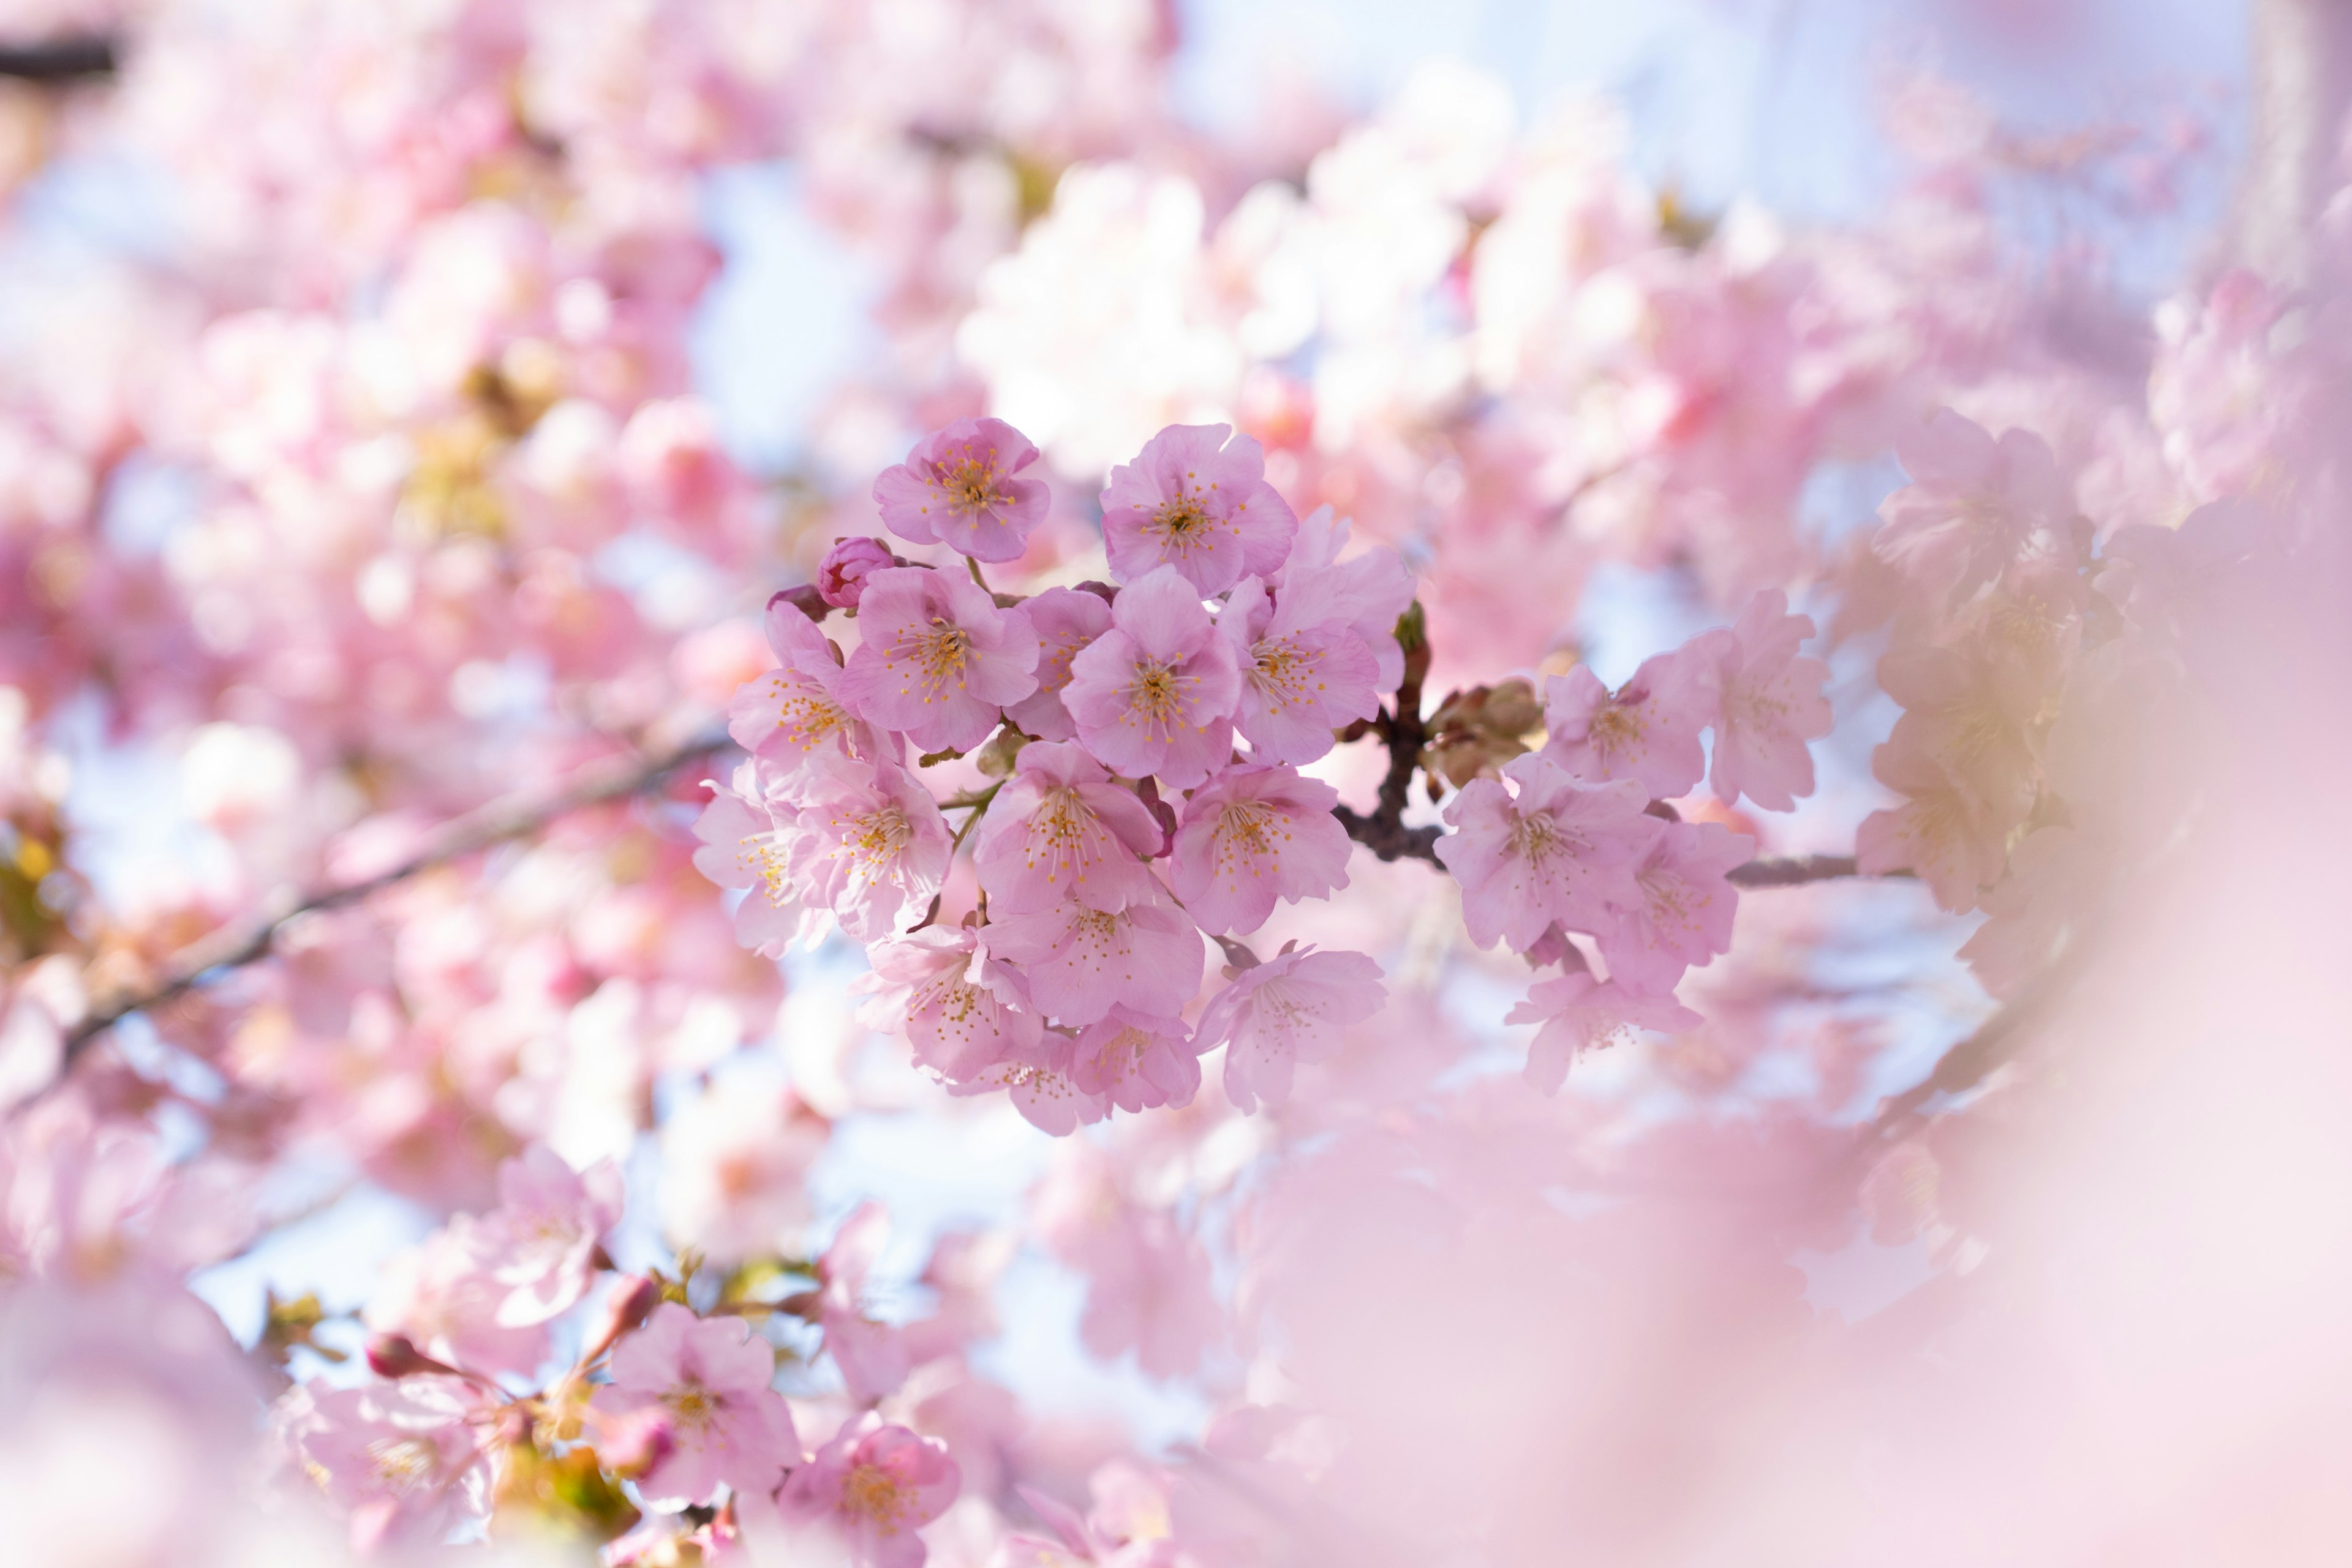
left=1169, top=766, right=1350, bottom=933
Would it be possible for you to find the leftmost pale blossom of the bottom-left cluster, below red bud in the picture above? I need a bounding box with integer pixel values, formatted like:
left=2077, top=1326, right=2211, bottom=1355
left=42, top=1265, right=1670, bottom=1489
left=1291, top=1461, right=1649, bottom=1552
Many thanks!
left=285, top=1378, right=492, bottom=1551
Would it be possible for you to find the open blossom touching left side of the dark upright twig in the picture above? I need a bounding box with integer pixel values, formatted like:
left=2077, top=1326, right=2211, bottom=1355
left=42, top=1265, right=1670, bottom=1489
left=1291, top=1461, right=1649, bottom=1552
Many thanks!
left=1216, top=576, right=1381, bottom=762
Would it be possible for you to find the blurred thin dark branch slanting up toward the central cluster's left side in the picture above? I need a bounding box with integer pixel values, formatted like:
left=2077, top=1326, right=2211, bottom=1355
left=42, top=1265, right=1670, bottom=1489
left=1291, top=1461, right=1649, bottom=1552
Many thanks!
left=59, top=729, right=727, bottom=1079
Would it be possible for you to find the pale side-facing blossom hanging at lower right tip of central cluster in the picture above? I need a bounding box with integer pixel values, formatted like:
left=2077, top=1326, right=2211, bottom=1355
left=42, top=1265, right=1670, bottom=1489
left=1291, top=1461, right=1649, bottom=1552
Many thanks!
left=1199, top=948, right=1388, bottom=1112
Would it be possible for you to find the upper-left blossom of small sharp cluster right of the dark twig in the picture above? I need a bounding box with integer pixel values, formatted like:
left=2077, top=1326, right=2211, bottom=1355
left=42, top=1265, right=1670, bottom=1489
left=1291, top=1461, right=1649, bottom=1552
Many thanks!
left=1543, top=632, right=1722, bottom=799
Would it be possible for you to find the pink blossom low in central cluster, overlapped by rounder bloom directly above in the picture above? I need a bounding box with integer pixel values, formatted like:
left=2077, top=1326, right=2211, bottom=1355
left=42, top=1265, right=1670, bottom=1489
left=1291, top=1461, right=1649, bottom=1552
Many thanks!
left=988, top=879, right=1202, bottom=1025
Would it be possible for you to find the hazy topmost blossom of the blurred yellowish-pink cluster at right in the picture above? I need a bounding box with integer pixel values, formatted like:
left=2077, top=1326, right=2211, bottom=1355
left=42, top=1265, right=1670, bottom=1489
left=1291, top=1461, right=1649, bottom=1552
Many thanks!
left=1872, top=409, right=2070, bottom=595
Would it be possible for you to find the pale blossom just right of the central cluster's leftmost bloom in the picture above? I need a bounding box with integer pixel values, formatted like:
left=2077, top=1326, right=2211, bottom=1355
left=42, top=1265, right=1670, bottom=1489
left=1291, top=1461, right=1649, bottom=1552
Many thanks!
left=790, top=757, right=952, bottom=943
